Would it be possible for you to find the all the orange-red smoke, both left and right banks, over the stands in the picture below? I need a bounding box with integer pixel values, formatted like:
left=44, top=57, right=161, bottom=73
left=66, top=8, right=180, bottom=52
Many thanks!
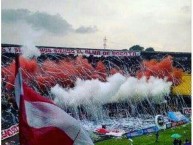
left=2, top=56, right=183, bottom=89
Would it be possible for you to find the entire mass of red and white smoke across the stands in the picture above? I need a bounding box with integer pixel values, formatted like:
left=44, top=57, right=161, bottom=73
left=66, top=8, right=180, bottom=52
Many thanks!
left=2, top=56, right=181, bottom=98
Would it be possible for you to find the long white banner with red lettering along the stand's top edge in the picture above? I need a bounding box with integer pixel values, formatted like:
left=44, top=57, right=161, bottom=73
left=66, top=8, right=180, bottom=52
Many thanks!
left=1, top=47, right=140, bottom=57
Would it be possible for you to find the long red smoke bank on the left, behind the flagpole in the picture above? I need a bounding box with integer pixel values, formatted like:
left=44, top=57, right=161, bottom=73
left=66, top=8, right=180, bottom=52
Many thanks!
left=2, top=56, right=117, bottom=89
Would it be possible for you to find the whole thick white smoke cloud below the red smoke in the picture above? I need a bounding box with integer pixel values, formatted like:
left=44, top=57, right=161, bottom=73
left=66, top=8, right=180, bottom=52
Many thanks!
left=51, top=73, right=172, bottom=106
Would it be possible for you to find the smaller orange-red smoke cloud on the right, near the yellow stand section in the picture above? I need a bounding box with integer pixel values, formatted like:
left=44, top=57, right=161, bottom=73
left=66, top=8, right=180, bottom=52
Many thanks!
left=137, top=56, right=183, bottom=85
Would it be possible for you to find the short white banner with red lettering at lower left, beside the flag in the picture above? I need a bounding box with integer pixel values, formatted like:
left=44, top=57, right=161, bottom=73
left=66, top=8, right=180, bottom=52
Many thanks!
left=1, top=124, right=19, bottom=140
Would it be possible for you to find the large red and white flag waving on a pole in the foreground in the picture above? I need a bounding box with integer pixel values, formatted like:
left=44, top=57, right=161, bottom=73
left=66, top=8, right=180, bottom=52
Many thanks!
left=15, top=57, right=94, bottom=145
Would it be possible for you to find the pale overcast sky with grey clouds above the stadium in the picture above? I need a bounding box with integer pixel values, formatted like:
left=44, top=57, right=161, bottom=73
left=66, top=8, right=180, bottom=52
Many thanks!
left=1, top=0, right=191, bottom=52
